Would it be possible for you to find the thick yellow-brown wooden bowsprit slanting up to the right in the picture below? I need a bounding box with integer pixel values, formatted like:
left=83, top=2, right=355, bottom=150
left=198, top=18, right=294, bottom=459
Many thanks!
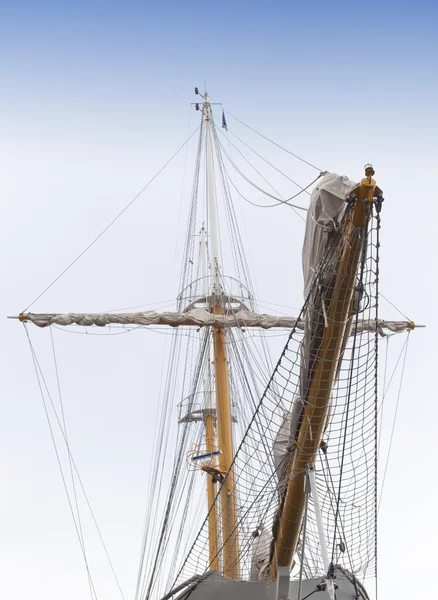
left=269, top=168, right=380, bottom=581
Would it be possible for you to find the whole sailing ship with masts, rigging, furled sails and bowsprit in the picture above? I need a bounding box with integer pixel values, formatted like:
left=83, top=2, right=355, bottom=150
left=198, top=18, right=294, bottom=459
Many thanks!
left=11, top=88, right=416, bottom=600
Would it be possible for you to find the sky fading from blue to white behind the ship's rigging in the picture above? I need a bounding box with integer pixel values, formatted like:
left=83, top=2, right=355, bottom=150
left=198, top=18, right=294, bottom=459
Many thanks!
left=0, top=0, right=438, bottom=600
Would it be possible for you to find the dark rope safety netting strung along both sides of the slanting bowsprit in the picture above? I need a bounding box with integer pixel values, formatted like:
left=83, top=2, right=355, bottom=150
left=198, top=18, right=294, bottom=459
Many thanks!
left=171, top=183, right=380, bottom=584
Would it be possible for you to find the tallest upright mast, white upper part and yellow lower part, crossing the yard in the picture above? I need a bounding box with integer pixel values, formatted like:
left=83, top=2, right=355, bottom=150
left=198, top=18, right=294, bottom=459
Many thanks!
left=203, top=93, right=240, bottom=579
